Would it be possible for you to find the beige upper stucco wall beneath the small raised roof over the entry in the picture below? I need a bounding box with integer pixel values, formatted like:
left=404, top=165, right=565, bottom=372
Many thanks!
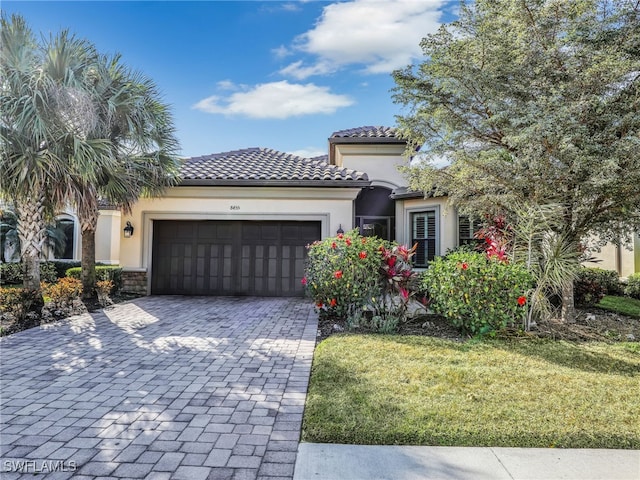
left=335, top=144, right=408, bottom=189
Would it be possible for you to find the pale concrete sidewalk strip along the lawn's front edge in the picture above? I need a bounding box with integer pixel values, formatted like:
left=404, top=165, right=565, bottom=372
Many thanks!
left=293, top=443, right=640, bottom=480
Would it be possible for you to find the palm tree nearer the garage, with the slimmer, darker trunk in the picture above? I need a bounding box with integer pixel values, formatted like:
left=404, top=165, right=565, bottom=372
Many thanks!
left=72, top=55, right=179, bottom=297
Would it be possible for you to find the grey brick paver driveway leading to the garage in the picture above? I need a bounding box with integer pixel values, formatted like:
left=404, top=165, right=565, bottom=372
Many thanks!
left=0, top=297, right=317, bottom=480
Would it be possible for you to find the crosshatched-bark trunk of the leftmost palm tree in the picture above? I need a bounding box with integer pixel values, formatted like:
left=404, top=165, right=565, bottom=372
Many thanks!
left=16, top=196, right=46, bottom=311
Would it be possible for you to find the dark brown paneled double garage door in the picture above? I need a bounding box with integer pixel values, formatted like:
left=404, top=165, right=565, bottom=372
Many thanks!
left=151, top=220, right=320, bottom=297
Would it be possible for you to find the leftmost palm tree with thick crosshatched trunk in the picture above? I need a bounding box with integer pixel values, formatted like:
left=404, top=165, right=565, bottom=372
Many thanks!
left=0, top=15, right=112, bottom=300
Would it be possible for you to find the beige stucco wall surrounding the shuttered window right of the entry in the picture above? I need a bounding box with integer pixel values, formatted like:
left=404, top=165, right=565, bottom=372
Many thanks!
left=396, top=197, right=458, bottom=255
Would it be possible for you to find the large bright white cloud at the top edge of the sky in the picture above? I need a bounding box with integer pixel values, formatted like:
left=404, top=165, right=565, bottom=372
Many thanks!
left=280, top=0, right=446, bottom=79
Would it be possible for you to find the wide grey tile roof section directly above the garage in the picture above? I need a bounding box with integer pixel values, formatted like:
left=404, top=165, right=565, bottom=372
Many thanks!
left=180, top=148, right=370, bottom=187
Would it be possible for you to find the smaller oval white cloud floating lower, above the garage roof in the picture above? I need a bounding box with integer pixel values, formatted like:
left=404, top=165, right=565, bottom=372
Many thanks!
left=192, top=81, right=354, bottom=119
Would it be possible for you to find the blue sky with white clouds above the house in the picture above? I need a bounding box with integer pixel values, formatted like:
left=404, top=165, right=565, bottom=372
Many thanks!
left=2, top=0, right=457, bottom=157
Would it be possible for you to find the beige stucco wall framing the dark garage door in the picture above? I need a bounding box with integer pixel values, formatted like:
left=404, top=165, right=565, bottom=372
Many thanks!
left=118, top=187, right=360, bottom=278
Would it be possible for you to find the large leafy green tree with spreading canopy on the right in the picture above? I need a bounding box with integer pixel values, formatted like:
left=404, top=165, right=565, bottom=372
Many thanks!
left=393, top=0, right=640, bottom=321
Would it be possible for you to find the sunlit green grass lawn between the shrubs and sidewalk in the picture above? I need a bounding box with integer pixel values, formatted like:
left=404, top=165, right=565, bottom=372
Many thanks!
left=302, top=335, right=640, bottom=449
